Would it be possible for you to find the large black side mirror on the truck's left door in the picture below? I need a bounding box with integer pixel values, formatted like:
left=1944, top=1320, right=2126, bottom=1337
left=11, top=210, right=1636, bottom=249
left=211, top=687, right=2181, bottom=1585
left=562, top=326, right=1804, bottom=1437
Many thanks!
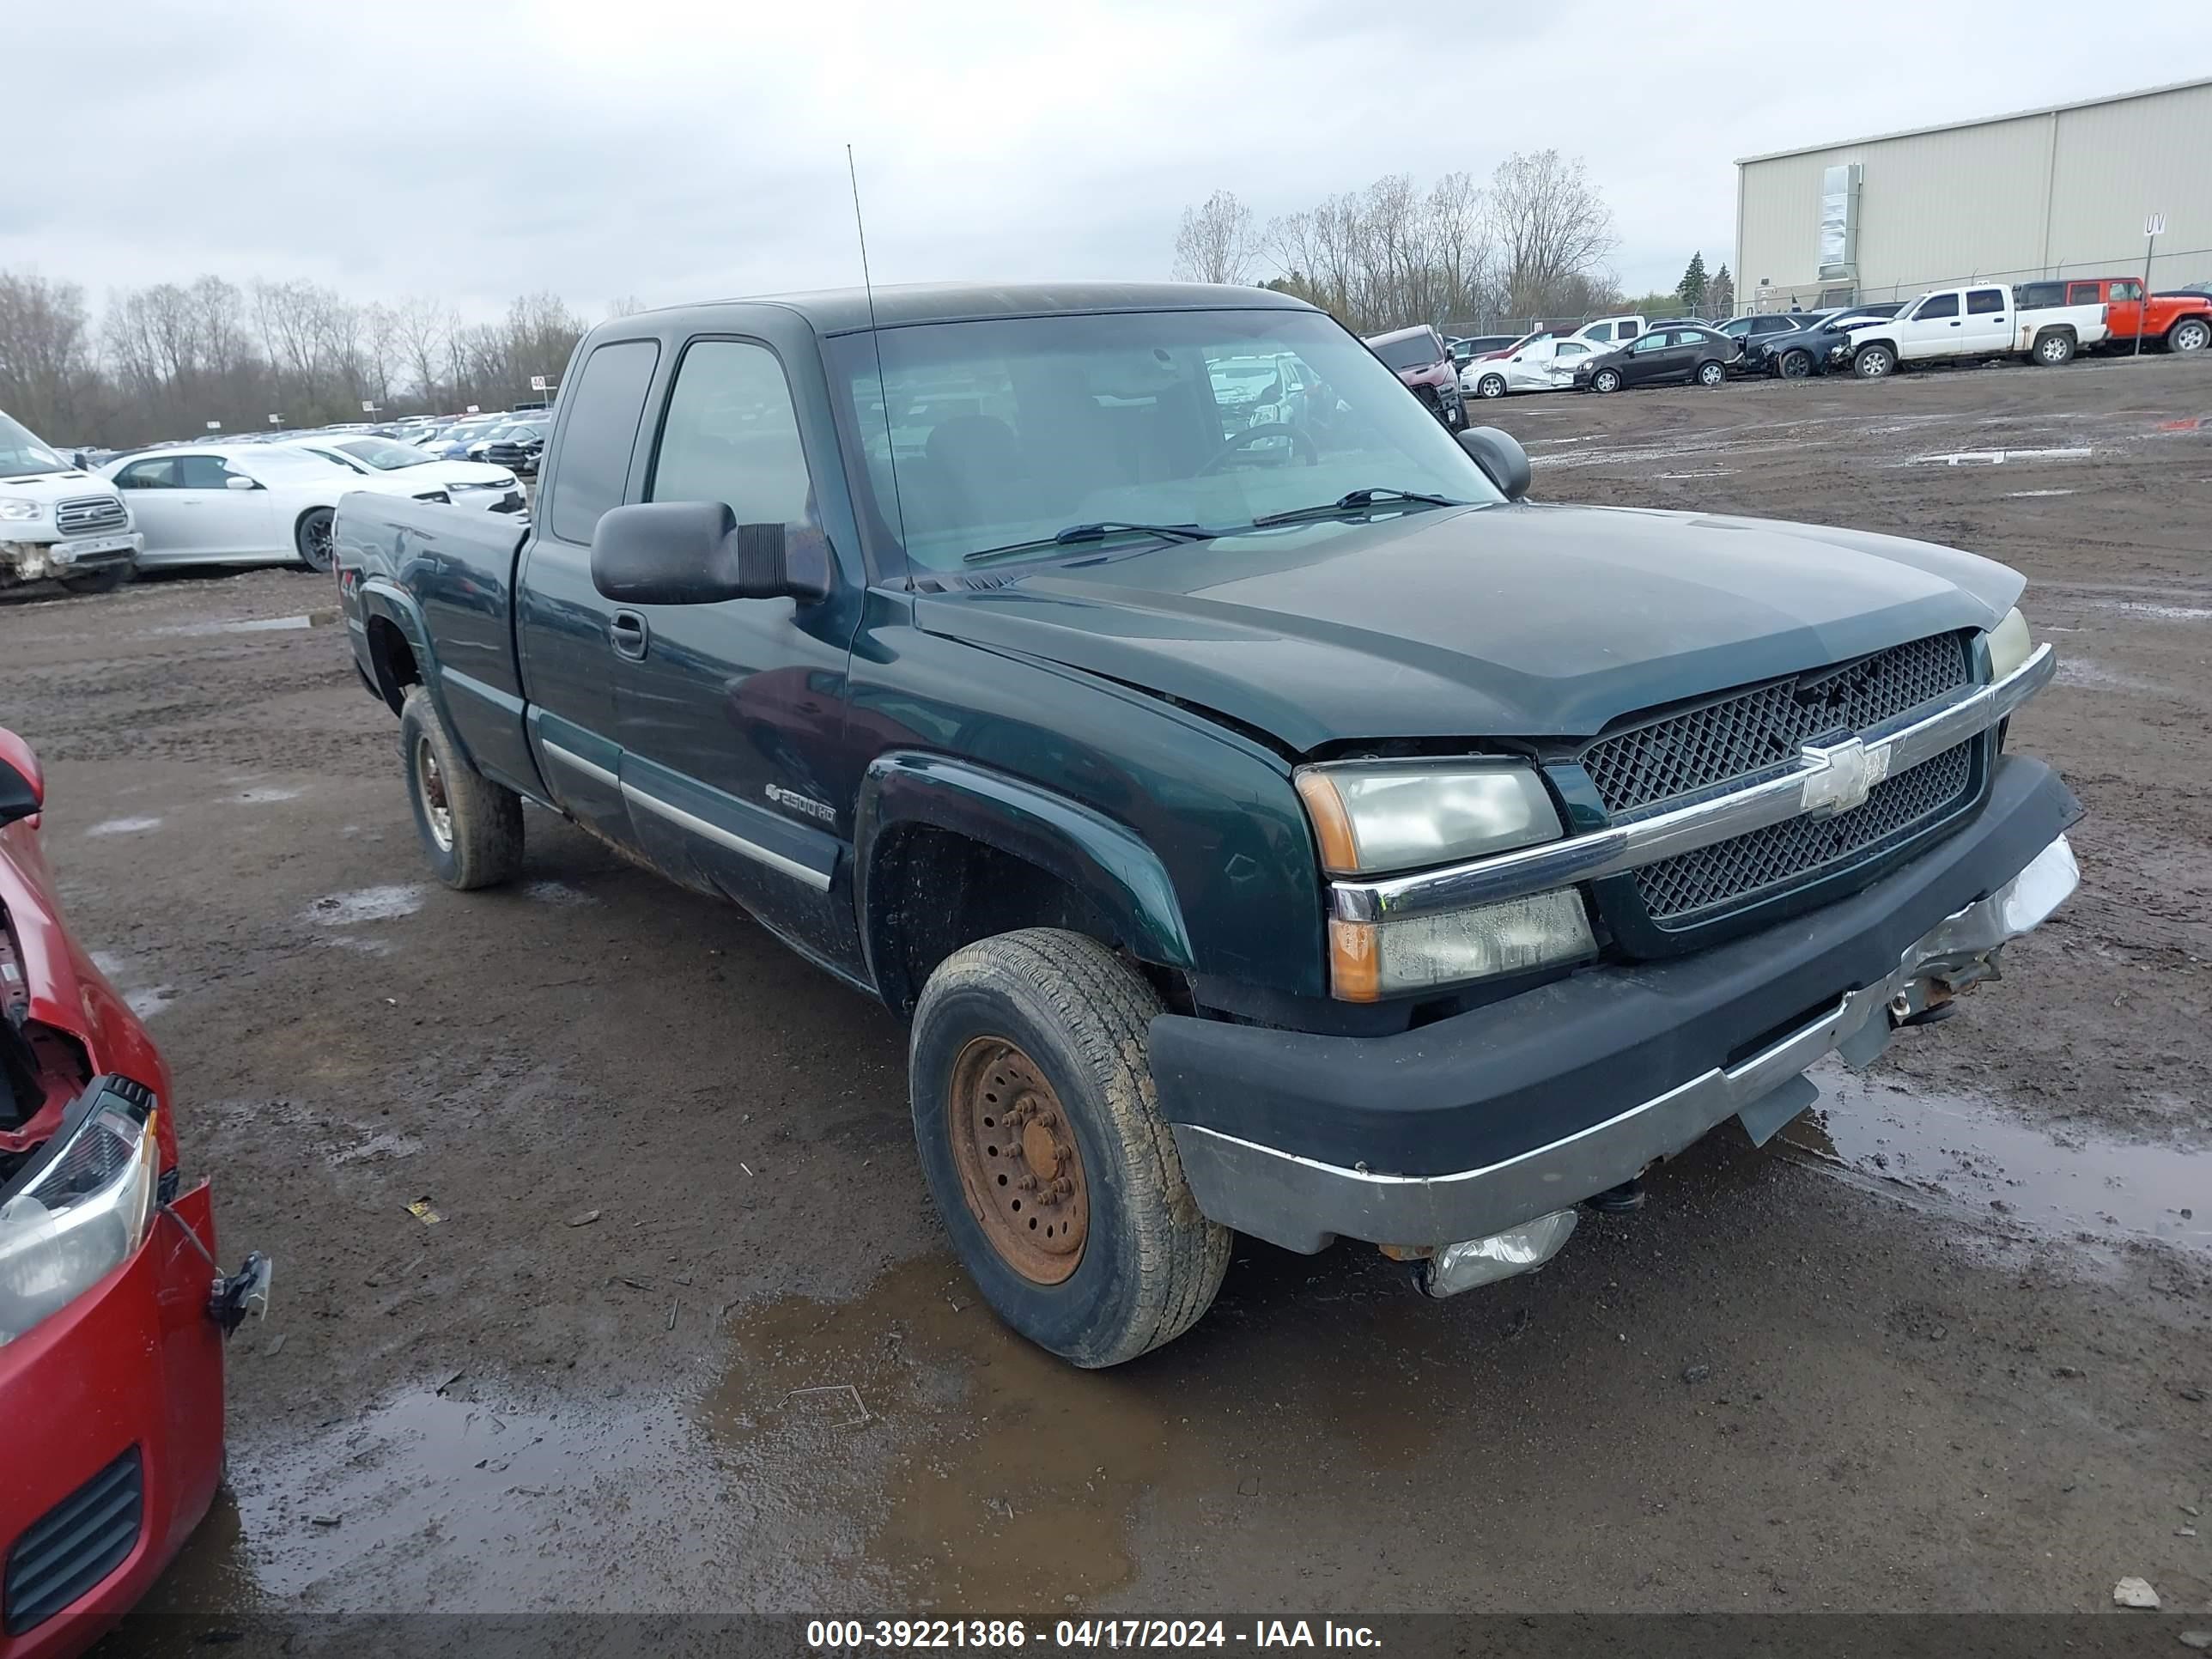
left=591, top=502, right=830, bottom=619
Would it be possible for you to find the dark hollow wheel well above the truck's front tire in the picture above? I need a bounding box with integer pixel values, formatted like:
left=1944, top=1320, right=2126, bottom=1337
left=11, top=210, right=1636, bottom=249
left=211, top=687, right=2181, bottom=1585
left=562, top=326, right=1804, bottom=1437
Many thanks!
left=867, top=825, right=1150, bottom=1015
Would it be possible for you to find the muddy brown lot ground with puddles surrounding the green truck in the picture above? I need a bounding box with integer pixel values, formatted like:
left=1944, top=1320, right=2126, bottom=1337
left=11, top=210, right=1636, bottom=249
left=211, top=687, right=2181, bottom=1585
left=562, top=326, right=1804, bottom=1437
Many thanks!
left=0, top=358, right=2212, bottom=1652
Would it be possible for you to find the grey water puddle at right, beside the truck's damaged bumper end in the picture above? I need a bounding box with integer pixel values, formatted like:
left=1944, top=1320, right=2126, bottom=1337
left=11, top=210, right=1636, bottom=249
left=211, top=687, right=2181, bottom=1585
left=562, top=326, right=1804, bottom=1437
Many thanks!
left=1781, top=1060, right=2212, bottom=1252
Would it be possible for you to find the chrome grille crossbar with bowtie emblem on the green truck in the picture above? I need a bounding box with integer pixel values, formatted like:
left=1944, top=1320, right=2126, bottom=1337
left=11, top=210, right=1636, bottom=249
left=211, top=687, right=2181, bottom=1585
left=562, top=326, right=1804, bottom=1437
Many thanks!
left=1329, top=644, right=2057, bottom=922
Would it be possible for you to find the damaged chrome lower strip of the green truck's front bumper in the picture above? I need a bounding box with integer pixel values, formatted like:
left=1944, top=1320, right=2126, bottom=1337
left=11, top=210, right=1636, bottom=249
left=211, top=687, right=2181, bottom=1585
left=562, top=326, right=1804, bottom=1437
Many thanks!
left=1172, top=836, right=2079, bottom=1252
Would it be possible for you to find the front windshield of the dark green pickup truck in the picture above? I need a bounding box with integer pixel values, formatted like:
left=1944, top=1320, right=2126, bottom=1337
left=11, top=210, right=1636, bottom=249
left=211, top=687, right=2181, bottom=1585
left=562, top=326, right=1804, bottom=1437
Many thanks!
left=830, top=310, right=1500, bottom=571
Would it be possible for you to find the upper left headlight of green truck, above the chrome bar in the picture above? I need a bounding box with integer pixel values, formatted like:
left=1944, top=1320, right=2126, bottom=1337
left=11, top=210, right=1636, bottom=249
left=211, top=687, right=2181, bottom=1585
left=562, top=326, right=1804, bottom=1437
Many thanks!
left=1294, top=761, right=1564, bottom=876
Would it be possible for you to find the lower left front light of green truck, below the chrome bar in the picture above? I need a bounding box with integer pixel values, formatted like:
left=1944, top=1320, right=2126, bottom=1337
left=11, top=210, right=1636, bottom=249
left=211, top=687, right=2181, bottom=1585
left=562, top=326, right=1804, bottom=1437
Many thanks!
left=1329, top=887, right=1597, bottom=1002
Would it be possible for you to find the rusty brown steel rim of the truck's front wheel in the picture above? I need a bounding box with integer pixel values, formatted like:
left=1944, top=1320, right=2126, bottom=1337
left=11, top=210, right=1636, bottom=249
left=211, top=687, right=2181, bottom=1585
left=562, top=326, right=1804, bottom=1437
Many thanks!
left=945, top=1037, right=1091, bottom=1285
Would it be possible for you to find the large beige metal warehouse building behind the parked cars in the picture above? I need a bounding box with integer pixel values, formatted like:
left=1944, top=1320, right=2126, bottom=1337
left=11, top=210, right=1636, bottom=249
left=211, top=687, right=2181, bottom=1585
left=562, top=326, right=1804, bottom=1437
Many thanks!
left=1736, top=80, right=2212, bottom=310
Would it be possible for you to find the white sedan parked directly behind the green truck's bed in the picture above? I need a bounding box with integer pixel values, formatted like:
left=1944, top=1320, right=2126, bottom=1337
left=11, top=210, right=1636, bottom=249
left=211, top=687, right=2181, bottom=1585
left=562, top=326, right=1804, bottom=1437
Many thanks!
left=100, top=445, right=452, bottom=571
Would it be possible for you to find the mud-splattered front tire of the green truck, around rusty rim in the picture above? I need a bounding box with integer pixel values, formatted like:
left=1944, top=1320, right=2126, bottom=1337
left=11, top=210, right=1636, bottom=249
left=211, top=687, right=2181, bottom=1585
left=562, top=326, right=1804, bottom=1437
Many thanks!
left=907, top=927, right=1232, bottom=1367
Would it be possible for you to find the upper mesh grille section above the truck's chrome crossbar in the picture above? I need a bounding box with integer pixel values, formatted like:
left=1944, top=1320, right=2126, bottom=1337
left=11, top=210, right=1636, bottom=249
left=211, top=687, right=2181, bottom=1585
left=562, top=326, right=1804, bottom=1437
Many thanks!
left=1582, top=633, right=1971, bottom=818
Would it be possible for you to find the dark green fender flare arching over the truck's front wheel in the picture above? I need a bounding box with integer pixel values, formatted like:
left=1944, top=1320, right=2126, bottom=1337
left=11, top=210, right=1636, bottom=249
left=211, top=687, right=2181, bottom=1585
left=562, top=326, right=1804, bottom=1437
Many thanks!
left=854, top=750, right=1194, bottom=1000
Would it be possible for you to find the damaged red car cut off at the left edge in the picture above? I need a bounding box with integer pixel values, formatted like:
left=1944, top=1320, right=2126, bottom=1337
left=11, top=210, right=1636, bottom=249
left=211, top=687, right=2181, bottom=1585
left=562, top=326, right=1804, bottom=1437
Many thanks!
left=0, top=730, right=268, bottom=1659
